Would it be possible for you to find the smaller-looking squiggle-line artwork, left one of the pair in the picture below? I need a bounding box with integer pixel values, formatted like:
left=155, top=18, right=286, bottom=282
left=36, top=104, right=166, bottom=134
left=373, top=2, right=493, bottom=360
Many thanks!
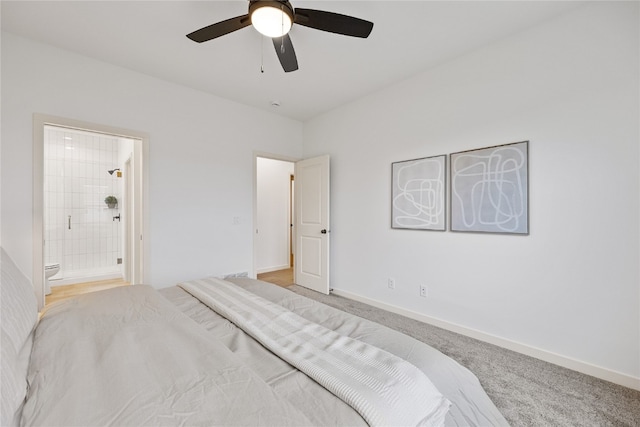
left=393, top=158, right=445, bottom=229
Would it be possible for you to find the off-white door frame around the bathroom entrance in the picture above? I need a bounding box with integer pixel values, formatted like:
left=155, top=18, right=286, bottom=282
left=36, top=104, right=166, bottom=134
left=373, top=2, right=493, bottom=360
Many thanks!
left=32, top=113, right=150, bottom=310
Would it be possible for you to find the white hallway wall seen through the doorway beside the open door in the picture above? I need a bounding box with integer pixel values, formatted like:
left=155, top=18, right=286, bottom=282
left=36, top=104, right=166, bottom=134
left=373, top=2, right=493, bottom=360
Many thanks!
left=256, top=157, right=294, bottom=273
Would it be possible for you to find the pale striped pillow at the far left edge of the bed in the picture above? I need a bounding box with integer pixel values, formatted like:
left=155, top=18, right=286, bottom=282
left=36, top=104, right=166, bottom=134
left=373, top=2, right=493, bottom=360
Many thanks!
left=0, top=248, right=38, bottom=426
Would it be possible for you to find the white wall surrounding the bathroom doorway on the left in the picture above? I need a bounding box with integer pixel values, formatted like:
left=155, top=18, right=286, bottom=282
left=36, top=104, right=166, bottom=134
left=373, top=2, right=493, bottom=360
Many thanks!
left=1, top=33, right=302, bottom=287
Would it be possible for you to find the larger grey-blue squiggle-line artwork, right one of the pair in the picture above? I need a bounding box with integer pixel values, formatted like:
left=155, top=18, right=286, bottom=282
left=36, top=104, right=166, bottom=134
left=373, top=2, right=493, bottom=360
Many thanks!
left=451, top=147, right=527, bottom=232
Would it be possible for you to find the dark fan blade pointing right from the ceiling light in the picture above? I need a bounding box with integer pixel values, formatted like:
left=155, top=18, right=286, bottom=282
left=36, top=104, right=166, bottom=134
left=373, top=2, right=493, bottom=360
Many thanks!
left=295, top=8, right=373, bottom=39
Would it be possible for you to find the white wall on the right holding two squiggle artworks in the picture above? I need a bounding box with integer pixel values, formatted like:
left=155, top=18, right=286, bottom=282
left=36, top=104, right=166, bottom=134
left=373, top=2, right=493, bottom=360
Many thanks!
left=303, top=2, right=640, bottom=387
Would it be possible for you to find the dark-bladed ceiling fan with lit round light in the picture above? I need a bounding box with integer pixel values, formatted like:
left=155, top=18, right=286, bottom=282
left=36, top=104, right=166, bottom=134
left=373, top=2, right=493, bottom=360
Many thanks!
left=187, top=0, right=373, bottom=73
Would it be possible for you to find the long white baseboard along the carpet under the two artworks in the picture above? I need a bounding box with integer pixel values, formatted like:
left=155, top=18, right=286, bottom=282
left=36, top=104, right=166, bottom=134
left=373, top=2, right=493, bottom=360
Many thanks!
left=332, top=289, right=640, bottom=390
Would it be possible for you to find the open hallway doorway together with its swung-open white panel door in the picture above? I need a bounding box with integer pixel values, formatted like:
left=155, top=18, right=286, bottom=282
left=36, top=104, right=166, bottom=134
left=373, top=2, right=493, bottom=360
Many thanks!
left=251, top=154, right=331, bottom=295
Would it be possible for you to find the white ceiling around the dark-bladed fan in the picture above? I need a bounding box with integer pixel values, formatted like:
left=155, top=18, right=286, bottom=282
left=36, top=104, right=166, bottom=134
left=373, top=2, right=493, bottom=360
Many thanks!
left=1, top=0, right=580, bottom=121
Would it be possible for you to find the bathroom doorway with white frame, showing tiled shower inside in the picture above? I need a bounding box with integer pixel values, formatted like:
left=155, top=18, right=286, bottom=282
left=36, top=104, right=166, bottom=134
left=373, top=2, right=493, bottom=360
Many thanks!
left=33, top=115, right=148, bottom=305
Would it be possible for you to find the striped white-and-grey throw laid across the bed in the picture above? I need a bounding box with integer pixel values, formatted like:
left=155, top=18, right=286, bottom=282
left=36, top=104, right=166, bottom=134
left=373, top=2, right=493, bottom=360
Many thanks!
left=178, top=278, right=450, bottom=426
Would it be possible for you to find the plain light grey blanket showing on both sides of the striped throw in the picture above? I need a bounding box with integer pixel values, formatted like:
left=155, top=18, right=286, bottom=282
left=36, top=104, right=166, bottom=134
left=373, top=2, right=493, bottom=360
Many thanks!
left=159, top=278, right=508, bottom=426
